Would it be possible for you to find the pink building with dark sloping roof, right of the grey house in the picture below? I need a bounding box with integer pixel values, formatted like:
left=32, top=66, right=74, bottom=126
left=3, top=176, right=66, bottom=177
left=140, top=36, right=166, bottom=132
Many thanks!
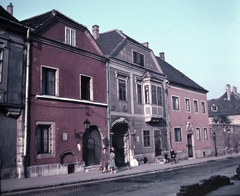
left=156, top=53, right=212, bottom=159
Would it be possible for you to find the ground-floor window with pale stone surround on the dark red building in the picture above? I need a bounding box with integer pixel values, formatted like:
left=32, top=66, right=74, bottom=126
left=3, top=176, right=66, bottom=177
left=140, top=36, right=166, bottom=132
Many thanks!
left=36, top=122, right=55, bottom=156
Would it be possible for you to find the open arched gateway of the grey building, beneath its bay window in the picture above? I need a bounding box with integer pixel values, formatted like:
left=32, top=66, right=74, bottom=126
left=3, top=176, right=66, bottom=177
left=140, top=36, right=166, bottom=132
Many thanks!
left=110, top=121, right=131, bottom=167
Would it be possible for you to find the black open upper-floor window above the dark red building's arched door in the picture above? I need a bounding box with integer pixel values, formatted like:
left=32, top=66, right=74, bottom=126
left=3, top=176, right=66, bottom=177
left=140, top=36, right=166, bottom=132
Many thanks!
left=80, top=75, right=93, bottom=101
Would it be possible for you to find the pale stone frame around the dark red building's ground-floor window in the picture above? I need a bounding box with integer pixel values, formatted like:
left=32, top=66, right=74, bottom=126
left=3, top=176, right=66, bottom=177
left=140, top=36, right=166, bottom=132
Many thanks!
left=35, top=121, right=55, bottom=159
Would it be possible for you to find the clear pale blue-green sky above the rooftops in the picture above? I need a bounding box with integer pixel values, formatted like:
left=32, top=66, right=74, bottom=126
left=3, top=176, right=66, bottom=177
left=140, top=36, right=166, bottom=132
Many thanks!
left=0, top=0, right=240, bottom=99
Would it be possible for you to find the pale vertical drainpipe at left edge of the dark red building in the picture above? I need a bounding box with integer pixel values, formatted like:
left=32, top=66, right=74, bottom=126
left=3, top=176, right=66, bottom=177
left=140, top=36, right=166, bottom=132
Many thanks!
left=23, top=29, right=30, bottom=177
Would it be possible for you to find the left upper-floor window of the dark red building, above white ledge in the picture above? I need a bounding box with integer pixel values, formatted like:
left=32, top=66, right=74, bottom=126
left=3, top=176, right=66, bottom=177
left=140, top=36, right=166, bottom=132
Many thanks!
left=42, top=67, right=57, bottom=95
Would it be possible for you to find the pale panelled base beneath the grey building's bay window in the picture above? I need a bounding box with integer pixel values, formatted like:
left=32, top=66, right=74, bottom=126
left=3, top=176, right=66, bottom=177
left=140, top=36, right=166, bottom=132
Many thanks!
left=144, top=104, right=164, bottom=122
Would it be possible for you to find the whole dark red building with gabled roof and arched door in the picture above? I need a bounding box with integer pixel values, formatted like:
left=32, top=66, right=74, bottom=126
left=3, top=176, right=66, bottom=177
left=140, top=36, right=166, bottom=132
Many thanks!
left=22, top=10, right=108, bottom=177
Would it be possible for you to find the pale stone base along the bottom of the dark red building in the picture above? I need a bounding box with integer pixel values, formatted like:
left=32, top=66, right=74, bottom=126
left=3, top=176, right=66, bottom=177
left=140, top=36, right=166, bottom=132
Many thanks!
left=27, top=164, right=85, bottom=178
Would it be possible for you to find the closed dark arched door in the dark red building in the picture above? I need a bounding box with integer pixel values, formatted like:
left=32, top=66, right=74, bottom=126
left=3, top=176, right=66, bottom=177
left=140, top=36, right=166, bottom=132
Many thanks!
left=83, top=126, right=102, bottom=166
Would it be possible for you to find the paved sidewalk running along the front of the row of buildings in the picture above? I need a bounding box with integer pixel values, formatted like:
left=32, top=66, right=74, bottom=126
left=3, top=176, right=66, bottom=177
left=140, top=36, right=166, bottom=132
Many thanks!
left=1, top=153, right=240, bottom=196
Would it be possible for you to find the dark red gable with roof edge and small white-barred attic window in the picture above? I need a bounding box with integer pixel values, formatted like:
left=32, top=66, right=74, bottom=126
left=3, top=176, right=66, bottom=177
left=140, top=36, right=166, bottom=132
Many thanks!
left=21, top=10, right=103, bottom=55
